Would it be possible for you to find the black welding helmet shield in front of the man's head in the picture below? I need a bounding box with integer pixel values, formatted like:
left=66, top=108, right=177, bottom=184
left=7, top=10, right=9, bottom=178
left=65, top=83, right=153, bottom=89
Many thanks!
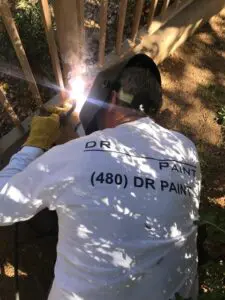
left=80, top=54, right=161, bottom=135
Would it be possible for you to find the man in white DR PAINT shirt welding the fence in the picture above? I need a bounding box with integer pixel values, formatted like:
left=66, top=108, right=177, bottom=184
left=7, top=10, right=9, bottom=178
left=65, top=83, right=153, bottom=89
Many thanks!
left=0, top=54, right=201, bottom=300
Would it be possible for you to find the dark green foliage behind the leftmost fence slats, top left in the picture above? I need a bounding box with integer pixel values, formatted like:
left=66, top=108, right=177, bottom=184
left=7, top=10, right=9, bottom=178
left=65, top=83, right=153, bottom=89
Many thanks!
left=0, top=0, right=52, bottom=79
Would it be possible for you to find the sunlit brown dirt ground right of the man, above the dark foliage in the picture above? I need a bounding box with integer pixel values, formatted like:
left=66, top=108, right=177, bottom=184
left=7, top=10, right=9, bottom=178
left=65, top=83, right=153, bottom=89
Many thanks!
left=159, top=10, right=225, bottom=204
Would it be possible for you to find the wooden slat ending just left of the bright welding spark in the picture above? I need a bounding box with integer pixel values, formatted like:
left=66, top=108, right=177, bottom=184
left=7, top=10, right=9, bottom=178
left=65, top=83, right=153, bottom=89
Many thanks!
left=40, top=0, right=64, bottom=100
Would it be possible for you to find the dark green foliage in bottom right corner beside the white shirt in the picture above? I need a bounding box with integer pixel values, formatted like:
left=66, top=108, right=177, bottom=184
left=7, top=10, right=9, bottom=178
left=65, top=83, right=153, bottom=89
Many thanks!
left=198, top=199, right=225, bottom=300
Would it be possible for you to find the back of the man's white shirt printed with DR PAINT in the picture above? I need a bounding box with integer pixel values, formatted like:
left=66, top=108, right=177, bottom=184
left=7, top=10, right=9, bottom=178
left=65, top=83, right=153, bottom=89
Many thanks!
left=33, top=118, right=200, bottom=300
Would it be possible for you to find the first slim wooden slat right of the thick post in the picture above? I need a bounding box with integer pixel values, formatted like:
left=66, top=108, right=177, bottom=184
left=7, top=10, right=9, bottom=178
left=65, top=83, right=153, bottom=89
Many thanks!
left=98, top=0, right=108, bottom=66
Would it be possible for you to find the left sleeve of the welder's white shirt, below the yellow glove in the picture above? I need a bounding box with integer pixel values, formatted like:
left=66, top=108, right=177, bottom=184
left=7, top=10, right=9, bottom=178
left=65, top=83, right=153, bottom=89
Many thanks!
left=0, top=147, right=46, bottom=226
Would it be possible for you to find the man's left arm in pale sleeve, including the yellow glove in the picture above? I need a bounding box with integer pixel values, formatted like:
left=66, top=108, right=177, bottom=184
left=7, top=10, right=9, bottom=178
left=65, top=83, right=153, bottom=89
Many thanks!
left=0, top=114, right=60, bottom=225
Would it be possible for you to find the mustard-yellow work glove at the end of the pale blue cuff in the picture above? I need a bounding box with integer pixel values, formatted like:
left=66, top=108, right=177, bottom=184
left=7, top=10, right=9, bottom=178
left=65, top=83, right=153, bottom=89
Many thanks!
left=24, top=114, right=60, bottom=150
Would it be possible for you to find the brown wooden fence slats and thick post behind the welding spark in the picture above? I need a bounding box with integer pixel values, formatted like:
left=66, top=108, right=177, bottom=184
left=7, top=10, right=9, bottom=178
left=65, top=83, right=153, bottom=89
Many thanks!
left=0, top=0, right=193, bottom=130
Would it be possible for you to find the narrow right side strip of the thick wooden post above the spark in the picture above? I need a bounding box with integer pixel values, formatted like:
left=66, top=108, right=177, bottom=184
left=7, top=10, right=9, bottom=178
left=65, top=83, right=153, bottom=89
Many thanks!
left=76, top=0, right=85, bottom=60
